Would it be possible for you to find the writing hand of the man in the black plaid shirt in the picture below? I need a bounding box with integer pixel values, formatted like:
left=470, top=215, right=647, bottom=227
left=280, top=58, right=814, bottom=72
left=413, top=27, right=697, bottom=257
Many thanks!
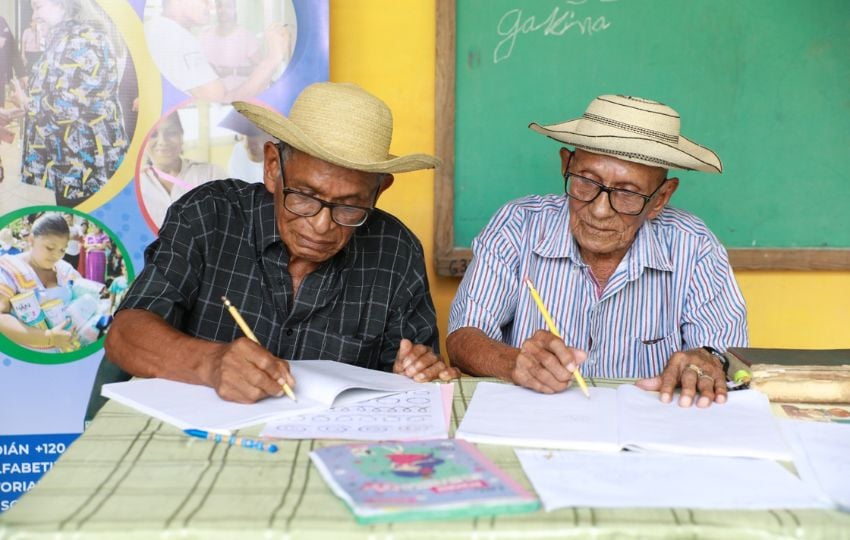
left=211, top=338, right=295, bottom=403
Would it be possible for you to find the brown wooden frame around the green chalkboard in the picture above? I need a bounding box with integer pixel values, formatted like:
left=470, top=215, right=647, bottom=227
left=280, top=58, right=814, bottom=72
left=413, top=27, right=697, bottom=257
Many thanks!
left=434, top=0, right=850, bottom=277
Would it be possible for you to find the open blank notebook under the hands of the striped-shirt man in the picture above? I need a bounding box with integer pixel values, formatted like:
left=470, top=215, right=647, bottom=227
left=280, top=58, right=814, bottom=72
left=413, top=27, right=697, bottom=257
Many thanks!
left=455, top=383, right=791, bottom=461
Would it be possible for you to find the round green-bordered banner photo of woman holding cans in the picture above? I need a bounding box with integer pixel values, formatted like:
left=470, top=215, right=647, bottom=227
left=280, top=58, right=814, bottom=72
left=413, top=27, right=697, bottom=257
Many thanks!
left=0, top=207, right=133, bottom=363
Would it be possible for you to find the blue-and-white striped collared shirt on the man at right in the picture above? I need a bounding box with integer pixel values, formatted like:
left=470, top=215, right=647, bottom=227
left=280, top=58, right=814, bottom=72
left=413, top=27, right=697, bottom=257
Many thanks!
left=449, top=195, right=747, bottom=377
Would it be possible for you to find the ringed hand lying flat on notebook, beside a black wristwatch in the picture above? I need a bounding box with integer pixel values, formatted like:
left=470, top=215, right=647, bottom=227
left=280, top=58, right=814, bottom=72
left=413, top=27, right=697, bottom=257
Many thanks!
left=635, top=349, right=726, bottom=407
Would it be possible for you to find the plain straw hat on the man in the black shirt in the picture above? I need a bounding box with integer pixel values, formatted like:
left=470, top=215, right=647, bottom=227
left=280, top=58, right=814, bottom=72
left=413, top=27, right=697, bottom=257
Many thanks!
left=233, top=82, right=440, bottom=173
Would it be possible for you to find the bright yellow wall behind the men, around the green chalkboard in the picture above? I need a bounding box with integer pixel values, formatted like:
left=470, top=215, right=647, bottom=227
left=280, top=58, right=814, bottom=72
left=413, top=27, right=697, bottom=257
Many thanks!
left=330, top=0, right=850, bottom=348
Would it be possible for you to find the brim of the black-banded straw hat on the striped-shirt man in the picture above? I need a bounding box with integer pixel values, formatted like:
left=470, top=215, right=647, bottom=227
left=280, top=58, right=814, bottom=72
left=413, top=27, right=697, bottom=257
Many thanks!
left=528, top=118, right=723, bottom=173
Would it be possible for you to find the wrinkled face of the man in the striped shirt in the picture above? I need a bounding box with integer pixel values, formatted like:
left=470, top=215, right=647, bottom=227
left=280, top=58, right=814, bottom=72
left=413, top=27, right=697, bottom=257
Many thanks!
left=561, top=149, right=675, bottom=258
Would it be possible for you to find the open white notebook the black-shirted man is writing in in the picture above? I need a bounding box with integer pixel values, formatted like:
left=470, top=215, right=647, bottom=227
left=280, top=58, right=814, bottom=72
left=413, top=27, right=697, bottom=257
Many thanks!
left=101, top=360, right=422, bottom=431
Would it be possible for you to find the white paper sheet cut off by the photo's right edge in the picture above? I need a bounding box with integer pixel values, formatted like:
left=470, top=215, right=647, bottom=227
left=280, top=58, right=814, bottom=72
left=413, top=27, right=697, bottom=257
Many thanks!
left=781, top=420, right=850, bottom=512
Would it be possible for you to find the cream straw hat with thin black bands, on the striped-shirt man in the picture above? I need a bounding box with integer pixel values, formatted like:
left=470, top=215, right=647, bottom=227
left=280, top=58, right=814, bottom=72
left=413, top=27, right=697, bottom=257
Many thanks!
left=528, top=95, right=723, bottom=173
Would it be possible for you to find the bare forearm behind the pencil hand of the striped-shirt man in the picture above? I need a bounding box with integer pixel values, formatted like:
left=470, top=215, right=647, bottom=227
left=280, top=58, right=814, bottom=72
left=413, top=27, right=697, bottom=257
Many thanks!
left=446, top=327, right=519, bottom=381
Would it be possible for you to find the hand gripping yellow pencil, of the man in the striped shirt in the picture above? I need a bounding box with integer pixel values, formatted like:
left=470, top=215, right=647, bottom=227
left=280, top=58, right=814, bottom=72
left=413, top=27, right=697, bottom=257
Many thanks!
left=514, top=278, right=590, bottom=399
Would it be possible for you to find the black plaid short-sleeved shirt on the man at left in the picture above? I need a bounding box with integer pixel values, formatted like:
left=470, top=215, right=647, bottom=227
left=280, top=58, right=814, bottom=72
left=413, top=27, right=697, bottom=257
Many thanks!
left=121, top=180, right=439, bottom=371
